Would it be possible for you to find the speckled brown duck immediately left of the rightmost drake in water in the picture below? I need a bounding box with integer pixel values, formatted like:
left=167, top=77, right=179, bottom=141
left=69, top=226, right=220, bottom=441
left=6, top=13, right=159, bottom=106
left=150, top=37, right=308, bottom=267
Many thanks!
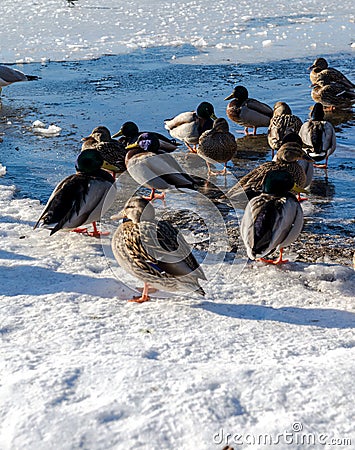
left=267, top=102, right=302, bottom=157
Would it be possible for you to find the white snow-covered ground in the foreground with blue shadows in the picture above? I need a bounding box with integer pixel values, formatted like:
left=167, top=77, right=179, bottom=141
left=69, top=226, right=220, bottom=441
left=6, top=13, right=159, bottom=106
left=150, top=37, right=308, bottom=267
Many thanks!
left=0, top=170, right=355, bottom=450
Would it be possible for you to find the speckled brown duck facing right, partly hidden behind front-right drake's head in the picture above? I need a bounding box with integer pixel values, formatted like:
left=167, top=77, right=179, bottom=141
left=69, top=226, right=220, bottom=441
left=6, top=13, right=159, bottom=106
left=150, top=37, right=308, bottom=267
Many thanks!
left=227, top=142, right=313, bottom=208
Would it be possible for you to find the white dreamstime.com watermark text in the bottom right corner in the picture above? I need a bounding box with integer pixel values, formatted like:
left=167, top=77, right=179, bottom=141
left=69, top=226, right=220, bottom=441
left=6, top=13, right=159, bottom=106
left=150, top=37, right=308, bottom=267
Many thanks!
left=213, top=422, right=352, bottom=448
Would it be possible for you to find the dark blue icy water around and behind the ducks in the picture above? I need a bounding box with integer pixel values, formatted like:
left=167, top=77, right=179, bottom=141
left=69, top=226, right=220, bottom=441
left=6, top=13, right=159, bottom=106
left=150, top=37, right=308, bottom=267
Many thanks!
left=0, top=47, right=355, bottom=260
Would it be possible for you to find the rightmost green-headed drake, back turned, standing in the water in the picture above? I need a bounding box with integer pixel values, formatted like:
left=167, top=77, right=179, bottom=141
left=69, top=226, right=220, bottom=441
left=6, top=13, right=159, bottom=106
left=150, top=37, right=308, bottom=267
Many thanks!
left=299, top=103, right=336, bottom=169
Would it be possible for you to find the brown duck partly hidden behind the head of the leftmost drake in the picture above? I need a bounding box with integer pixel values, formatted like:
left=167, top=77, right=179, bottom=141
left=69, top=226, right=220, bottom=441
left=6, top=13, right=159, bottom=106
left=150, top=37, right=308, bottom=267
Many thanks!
left=82, top=126, right=127, bottom=177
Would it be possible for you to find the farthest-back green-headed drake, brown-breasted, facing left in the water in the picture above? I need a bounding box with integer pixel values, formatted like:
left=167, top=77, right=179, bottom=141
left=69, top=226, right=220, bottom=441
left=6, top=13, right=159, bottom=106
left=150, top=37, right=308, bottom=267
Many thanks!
left=224, top=86, right=273, bottom=136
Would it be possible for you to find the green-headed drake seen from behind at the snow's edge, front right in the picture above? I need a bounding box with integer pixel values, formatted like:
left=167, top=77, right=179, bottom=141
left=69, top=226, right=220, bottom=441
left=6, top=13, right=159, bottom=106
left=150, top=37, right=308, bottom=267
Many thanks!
left=240, top=170, right=303, bottom=264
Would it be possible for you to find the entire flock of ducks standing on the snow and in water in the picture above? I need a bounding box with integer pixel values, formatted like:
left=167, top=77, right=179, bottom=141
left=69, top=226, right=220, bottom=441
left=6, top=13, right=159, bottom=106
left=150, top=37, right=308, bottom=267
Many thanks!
left=0, top=58, right=355, bottom=303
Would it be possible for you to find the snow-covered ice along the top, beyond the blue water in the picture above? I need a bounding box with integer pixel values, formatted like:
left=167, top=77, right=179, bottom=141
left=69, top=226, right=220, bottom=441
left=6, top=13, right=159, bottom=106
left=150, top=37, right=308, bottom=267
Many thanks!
left=0, top=0, right=354, bottom=64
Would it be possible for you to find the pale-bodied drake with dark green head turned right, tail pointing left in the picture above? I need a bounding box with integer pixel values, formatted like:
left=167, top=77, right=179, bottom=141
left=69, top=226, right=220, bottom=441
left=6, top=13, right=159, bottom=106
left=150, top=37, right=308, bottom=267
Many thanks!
left=164, top=102, right=217, bottom=153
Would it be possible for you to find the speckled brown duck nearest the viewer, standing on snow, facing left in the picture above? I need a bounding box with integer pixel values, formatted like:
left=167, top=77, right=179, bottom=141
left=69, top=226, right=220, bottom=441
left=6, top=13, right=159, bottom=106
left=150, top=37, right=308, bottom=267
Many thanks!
left=111, top=196, right=206, bottom=303
